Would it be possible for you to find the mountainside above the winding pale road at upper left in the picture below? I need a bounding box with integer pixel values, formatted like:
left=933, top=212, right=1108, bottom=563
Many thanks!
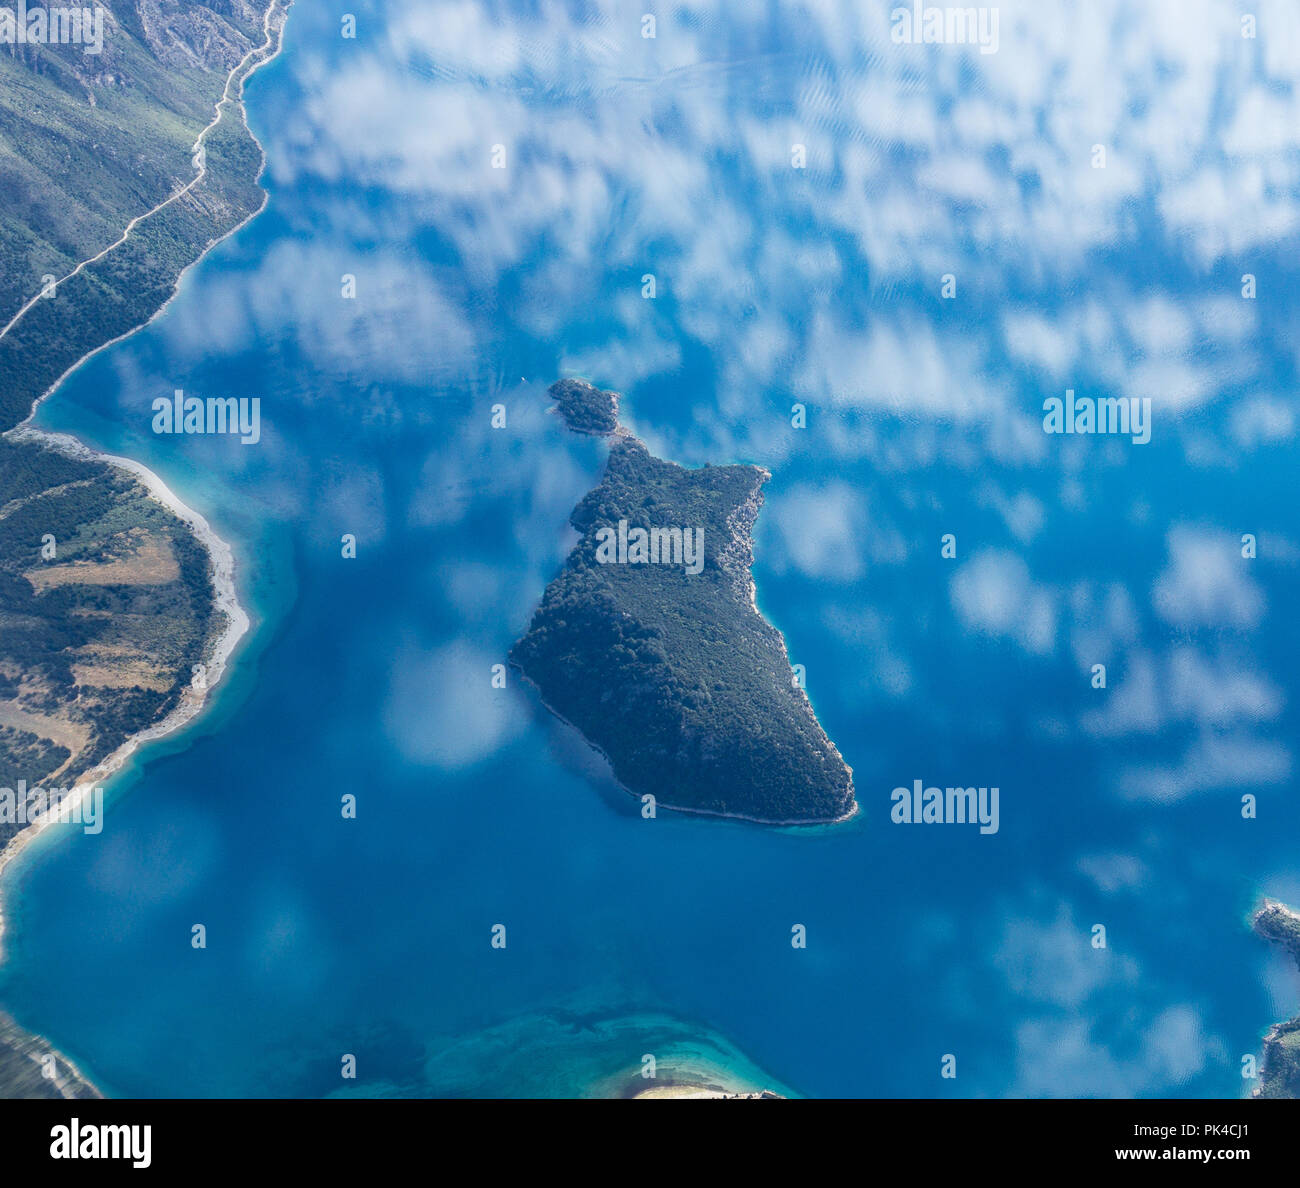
left=0, top=0, right=264, bottom=325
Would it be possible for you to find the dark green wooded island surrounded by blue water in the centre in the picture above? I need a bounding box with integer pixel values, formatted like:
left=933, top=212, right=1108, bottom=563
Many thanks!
left=510, top=380, right=857, bottom=824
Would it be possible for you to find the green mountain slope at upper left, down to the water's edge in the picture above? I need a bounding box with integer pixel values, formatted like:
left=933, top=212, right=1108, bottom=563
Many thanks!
left=0, top=0, right=286, bottom=430
